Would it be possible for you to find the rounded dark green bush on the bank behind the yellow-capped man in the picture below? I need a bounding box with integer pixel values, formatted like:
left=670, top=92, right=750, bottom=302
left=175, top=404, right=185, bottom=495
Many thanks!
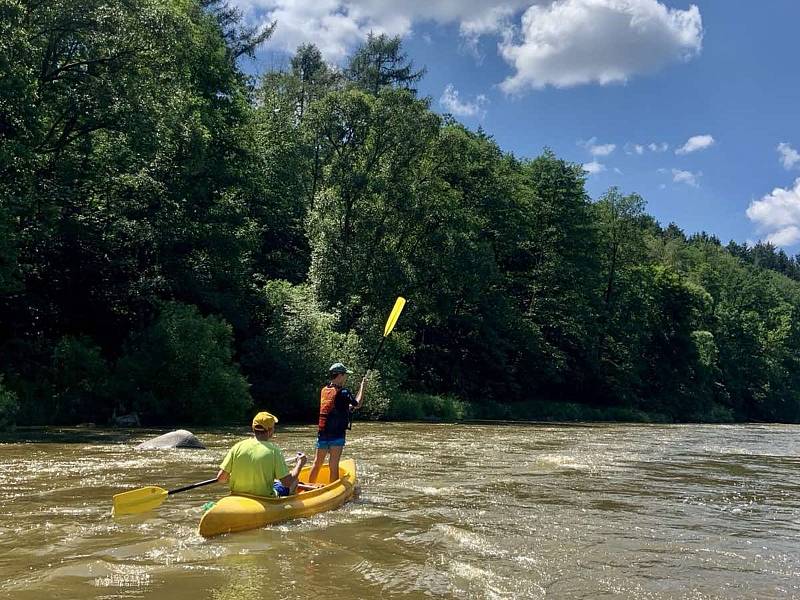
left=117, top=303, right=253, bottom=424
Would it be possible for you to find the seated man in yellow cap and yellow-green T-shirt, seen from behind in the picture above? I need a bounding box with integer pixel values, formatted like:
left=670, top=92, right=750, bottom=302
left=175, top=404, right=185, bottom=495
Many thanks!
left=217, top=412, right=306, bottom=497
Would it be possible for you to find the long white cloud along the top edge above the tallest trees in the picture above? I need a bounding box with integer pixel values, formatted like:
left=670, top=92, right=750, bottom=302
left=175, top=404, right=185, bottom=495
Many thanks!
left=231, top=0, right=536, bottom=62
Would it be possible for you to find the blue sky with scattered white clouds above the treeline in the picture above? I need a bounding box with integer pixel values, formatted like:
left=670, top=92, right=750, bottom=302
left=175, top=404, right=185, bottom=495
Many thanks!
left=232, top=0, right=800, bottom=254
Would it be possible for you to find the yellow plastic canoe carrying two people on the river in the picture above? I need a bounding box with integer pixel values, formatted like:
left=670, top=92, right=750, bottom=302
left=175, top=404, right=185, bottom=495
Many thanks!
left=200, top=459, right=356, bottom=537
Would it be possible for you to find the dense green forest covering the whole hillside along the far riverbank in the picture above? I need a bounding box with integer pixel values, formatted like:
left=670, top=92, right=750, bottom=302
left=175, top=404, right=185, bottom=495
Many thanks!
left=0, top=0, right=800, bottom=427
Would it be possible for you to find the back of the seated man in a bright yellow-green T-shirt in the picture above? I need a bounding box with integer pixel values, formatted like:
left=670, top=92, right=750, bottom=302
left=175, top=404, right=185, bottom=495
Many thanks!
left=220, top=438, right=289, bottom=496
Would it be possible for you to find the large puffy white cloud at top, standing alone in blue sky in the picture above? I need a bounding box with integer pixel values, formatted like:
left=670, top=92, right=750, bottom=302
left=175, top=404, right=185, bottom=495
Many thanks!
left=500, top=0, right=703, bottom=93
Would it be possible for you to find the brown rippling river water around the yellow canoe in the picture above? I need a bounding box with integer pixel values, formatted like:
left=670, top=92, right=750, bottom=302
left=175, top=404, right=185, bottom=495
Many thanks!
left=0, top=423, right=800, bottom=600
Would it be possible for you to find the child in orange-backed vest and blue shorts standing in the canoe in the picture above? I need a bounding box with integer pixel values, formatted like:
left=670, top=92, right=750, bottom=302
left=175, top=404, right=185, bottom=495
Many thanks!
left=308, top=363, right=367, bottom=483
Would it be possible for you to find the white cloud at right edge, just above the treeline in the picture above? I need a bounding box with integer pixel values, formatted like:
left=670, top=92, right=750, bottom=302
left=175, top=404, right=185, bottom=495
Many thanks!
left=747, top=178, right=800, bottom=246
